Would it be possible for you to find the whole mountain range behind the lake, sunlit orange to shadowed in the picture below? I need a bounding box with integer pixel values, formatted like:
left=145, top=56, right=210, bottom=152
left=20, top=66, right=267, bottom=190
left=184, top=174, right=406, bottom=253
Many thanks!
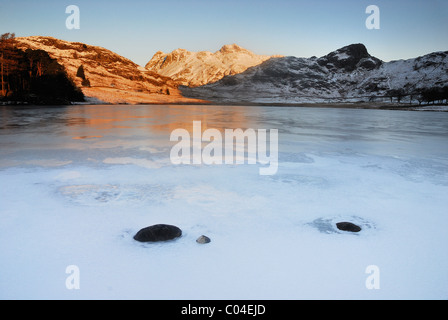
left=10, top=36, right=448, bottom=104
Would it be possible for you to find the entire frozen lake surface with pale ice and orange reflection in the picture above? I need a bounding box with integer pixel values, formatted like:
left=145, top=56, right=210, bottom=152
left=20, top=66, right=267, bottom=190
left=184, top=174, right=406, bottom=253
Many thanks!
left=0, top=105, right=448, bottom=300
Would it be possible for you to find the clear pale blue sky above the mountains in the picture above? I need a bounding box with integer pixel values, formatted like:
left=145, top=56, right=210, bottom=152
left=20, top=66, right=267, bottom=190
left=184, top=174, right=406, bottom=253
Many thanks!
left=0, top=0, right=448, bottom=65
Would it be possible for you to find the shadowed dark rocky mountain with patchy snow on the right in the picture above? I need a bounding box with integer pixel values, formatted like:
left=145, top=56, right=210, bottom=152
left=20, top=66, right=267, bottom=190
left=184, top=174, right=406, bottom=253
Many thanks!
left=181, top=44, right=448, bottom=103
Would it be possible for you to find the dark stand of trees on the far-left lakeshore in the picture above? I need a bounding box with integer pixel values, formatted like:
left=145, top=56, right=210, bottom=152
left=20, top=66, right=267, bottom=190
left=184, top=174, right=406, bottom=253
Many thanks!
left=0, top=33, right=84, bottom=104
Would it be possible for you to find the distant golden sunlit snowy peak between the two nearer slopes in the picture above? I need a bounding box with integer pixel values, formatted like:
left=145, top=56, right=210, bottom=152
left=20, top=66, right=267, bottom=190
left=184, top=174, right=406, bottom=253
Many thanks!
left=145, top=44, right=280, bottom=87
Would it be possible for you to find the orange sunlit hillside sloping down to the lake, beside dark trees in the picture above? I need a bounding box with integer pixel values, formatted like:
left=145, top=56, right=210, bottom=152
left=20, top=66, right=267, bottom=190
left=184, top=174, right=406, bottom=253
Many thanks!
left=16, top=36, right=206, bottom=104
